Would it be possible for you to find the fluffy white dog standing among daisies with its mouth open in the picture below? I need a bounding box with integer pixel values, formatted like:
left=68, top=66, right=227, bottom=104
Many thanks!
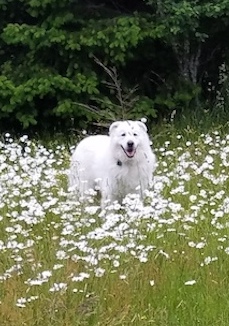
left=69, top=121, right=156, bottom=207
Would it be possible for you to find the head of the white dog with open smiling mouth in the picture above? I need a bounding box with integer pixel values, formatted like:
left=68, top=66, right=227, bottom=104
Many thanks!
left=109, top=120, right=149, bottom=159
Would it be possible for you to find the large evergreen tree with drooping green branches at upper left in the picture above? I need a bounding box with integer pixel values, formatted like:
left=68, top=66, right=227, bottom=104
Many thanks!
left=0, top=0, right=158, bottom=127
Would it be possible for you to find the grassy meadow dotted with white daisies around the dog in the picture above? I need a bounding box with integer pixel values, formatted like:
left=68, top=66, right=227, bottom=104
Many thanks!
left=0, top=127, right=229, bottom=326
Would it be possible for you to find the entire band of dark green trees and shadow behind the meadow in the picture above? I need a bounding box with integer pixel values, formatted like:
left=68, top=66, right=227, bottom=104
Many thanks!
left=0, top=0, right=229, bottom=131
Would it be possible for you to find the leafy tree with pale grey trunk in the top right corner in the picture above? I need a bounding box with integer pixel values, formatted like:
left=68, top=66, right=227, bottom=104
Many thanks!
left=146, top=0, right=229, bottom=84
